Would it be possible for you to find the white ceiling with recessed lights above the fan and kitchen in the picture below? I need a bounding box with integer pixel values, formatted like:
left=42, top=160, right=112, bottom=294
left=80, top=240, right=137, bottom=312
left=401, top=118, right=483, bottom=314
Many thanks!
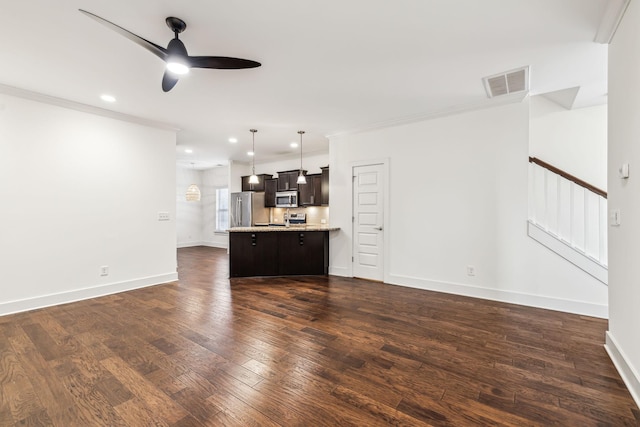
left=0, top=0, right=613, bottom=167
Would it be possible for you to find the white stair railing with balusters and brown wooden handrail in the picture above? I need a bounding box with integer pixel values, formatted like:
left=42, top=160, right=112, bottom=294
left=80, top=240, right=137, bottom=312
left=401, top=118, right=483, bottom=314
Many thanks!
left=528, top=157, right=608, bottom=284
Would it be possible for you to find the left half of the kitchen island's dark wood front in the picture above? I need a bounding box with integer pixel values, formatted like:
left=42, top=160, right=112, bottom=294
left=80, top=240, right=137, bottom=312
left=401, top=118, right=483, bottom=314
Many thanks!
left=229, top=233, right=279, bottom=277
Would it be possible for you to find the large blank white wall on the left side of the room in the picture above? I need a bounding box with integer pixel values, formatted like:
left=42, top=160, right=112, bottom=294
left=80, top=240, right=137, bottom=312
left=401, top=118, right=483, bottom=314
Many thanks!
left=0, top=95, right=177, bottom=314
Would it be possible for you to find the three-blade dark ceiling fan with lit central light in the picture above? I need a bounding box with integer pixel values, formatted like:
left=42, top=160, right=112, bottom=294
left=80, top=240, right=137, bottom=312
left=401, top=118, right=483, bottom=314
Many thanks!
left=78, top=9, right=262, bottom=92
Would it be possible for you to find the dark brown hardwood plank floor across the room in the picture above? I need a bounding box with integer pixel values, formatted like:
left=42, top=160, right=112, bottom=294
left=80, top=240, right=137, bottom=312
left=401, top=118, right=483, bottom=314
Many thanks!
left=0, top=248, right=640, bottom=427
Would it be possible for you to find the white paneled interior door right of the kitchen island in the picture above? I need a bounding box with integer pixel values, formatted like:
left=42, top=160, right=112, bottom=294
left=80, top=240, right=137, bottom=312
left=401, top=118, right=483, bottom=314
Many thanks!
left=353, top=164, right=384, bottom=281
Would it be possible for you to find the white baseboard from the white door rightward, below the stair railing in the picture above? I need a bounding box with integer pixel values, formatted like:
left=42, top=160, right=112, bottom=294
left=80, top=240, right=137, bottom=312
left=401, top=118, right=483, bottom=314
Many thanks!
left=386, top=274, right=609, bottom=319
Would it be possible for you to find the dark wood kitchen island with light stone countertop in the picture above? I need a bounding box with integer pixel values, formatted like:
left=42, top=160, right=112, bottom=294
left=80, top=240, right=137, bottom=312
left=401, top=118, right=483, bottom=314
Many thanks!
left=229, top=225, right=339, bottom=277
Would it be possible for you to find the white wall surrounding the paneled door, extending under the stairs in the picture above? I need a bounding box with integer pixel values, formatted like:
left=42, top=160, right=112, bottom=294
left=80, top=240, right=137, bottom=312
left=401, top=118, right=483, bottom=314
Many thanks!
left=330, top=102, right=607, bottom=317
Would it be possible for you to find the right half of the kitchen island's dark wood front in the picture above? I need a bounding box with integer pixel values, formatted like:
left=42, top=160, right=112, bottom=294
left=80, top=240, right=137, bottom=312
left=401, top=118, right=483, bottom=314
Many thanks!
left=278, top=231, right=329, bottom=276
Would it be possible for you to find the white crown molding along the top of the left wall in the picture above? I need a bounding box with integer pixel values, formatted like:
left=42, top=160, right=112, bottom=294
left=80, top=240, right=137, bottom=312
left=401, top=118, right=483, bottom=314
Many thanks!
left=0, top=84, right=180, bottom=132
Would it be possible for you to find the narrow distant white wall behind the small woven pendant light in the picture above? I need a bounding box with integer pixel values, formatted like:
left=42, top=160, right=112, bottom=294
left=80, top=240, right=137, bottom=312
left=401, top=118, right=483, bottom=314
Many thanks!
left=176, top=166, right=205, bottom=248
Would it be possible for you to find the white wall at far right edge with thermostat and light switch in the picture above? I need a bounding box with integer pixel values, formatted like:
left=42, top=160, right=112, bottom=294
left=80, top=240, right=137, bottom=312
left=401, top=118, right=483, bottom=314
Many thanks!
left=607, top=2, right=640, bottom=405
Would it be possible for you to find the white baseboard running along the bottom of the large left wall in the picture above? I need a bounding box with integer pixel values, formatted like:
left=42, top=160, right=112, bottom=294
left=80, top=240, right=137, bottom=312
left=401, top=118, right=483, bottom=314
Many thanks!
left=0, top=272, right=178, bottom=316
